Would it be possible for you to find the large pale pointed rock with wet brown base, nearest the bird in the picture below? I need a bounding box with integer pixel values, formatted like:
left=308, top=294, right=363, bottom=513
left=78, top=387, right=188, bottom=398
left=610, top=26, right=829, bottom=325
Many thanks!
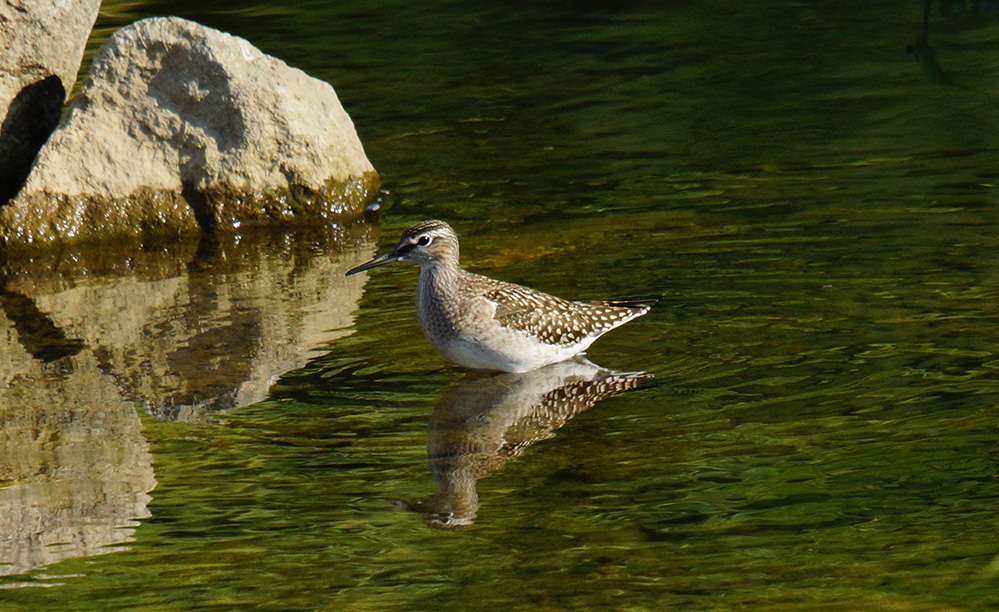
left=0, top=18, right=378, bottom=246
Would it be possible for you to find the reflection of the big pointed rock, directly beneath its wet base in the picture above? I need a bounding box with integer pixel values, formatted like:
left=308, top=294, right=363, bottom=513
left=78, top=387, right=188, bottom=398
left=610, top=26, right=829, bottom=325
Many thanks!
left=0, top=227, right=374, bottom=421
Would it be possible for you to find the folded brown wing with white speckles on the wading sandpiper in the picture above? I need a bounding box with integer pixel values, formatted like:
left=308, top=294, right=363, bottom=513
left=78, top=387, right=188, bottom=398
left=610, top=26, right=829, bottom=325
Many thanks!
left=482, top=281, right=649, bottom=345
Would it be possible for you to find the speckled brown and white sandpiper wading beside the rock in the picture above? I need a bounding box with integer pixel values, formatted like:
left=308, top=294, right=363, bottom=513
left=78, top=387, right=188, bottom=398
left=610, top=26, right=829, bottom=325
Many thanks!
left=347, top=220, right=654, bottom=372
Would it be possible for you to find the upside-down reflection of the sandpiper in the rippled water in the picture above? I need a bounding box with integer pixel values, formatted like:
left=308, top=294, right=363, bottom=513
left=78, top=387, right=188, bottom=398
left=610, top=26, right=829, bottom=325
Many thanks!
left=409, top=358, right=652, bottom=529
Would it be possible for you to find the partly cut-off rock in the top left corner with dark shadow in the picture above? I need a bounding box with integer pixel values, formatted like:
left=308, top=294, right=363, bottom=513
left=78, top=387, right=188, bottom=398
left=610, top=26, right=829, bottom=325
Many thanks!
left=0, top=0, right=101, bottom=204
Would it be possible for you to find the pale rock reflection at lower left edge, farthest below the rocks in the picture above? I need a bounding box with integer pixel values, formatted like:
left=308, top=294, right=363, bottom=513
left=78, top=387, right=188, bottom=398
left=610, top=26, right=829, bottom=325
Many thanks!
left=0, top=350, right=156, bottom=575
